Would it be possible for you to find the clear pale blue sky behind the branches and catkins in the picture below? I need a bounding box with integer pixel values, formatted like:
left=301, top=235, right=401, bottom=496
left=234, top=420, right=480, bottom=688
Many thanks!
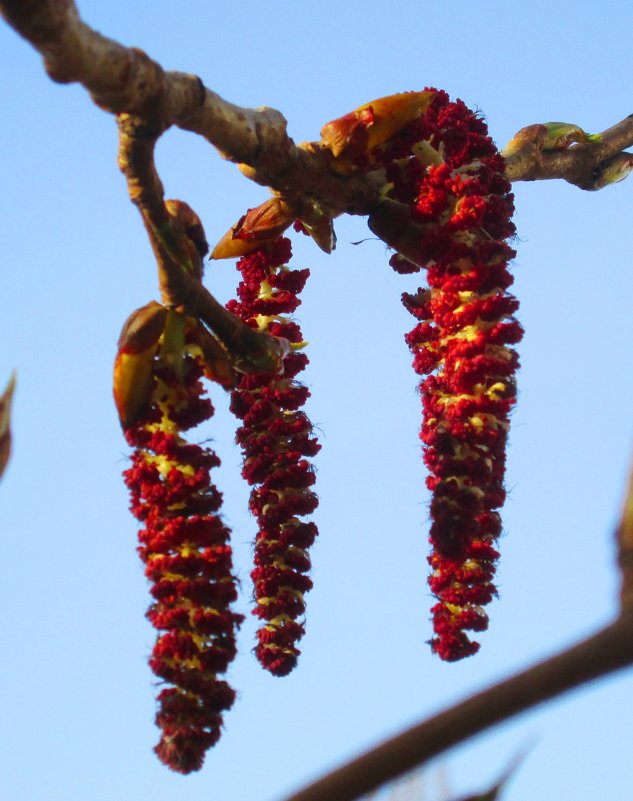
left=0, top=0, right=633, bottom=801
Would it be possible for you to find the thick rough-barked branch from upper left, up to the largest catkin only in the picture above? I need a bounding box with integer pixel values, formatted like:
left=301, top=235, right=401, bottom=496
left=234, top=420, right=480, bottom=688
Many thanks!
left=0, top=0, right=376, bottom=216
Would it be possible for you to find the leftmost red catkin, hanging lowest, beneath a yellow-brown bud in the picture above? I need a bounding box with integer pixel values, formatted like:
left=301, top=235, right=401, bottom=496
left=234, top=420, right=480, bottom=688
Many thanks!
left=121, top=304, right=242, bottom=773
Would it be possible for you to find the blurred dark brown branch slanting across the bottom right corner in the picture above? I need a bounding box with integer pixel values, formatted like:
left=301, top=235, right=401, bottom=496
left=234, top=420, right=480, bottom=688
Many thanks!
left=278, top=613, right=633, bottom=801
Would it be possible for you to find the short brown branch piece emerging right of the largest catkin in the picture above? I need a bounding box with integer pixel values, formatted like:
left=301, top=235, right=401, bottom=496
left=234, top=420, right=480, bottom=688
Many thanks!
left=506, top=115, right=633, bottom=190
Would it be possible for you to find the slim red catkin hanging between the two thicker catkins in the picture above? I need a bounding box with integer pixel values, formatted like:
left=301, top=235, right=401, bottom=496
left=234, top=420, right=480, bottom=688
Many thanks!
left=227, top=238, right=320, bottom=676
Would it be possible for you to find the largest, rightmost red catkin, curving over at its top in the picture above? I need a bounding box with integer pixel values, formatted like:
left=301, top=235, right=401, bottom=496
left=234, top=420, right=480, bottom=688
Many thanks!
left=376, top=92, right=522, bottom=661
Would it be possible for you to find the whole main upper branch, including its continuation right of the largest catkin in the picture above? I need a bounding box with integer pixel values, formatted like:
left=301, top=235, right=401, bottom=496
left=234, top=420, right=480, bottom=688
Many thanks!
left=0, top=0, right=633, bottom=209
